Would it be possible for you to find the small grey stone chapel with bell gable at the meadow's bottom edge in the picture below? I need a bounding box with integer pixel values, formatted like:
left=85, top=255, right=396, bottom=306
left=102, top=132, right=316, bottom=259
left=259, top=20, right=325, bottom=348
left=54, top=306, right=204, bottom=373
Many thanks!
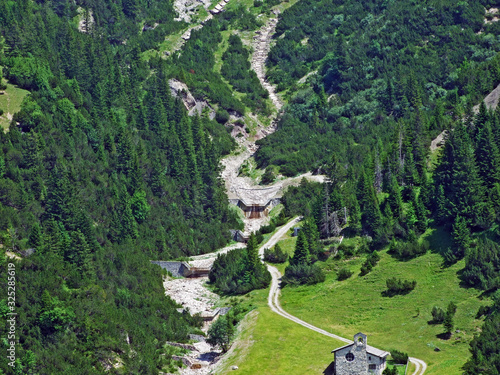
left=332, top=333, right=389, bottom=375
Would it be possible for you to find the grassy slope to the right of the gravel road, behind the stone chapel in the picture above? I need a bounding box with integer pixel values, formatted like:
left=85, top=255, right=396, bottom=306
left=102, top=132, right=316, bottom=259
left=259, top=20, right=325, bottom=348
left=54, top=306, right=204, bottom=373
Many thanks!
left=281, top=245, right=487, bottom=375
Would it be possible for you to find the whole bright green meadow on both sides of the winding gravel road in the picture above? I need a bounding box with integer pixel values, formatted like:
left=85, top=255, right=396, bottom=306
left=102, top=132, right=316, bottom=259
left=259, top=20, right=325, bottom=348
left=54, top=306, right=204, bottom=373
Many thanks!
left=228, top=230, right=490, bottom=375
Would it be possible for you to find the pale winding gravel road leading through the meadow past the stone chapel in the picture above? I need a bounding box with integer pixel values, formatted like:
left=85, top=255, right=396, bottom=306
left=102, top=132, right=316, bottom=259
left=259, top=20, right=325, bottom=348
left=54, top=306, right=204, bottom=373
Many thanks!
left=259, top=217, right=427, bottom=375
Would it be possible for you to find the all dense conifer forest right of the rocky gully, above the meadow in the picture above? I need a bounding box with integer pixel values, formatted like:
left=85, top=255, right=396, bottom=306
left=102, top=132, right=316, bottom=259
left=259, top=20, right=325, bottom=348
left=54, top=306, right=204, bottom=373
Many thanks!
left=270, top=1, right=500, bottom=374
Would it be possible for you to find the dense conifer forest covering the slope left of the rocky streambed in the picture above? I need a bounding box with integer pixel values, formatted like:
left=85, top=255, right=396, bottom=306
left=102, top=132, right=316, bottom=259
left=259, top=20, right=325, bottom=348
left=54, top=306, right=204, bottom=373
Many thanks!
left=0, top=0, right=239, bottom=374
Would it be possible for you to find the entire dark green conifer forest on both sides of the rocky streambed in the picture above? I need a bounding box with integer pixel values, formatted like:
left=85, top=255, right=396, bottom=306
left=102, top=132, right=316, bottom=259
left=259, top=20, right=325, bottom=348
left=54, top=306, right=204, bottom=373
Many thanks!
left=0, top=0, right=500, bottom=374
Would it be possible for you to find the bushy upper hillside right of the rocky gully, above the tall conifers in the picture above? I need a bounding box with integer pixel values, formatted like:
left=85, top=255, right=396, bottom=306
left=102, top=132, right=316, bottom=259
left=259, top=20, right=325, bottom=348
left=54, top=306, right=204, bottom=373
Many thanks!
left=256, top=0, right=500, bottom=175
